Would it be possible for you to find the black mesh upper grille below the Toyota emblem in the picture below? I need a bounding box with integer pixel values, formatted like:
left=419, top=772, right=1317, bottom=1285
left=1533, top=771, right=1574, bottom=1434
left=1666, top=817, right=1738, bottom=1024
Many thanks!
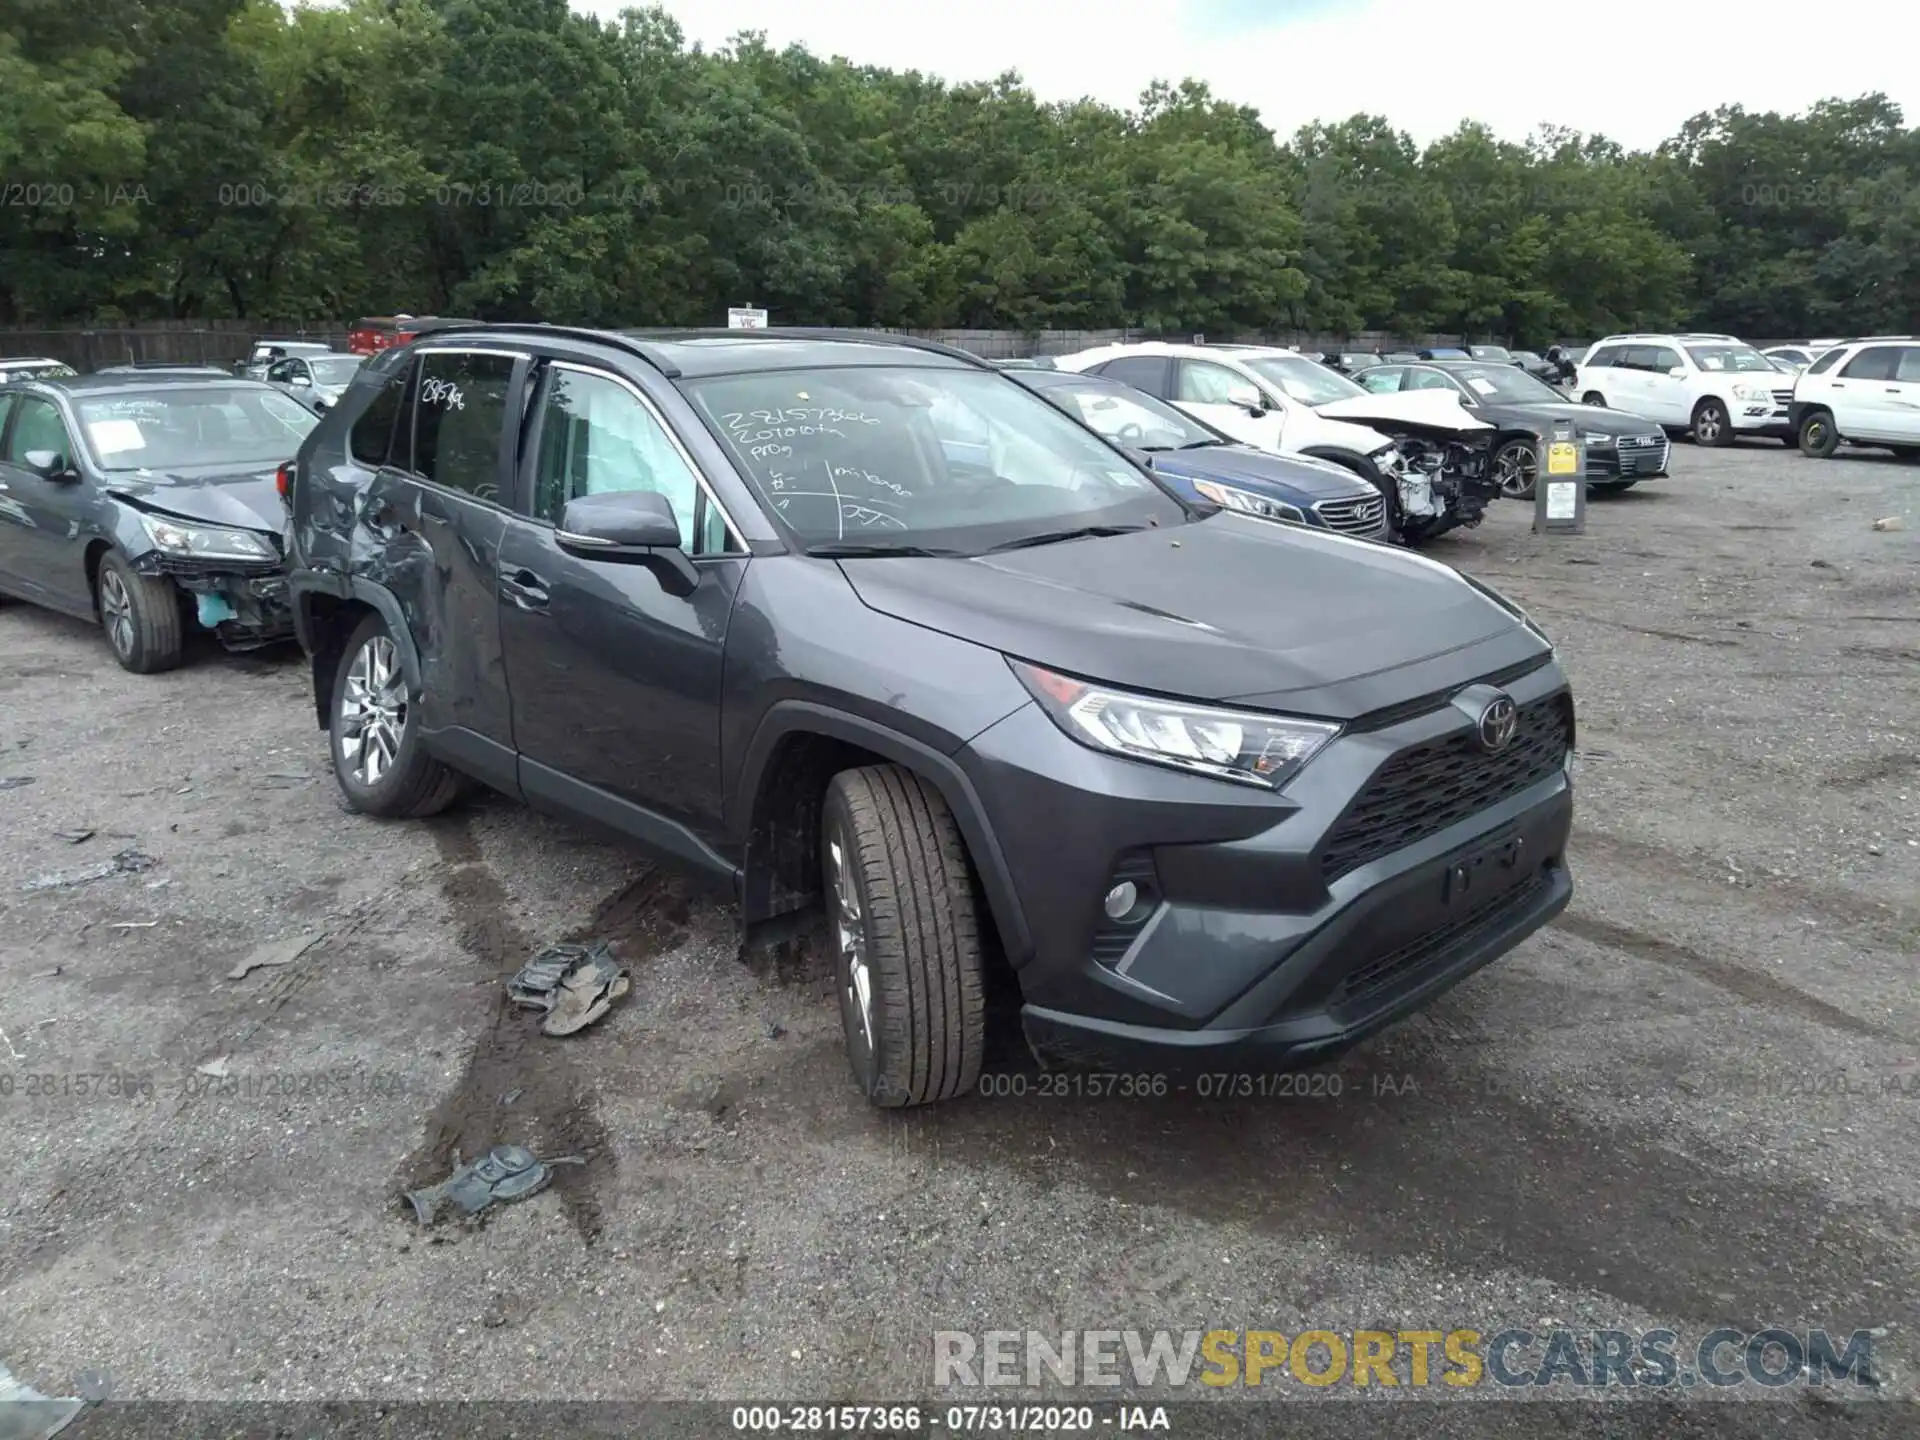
left=1321, top=691, right=1572, bottom=885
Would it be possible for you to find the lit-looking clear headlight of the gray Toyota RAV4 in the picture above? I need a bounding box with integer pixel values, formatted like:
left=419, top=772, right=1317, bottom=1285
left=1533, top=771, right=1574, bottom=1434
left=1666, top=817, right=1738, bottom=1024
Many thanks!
left=1008, top=660, right=1340, bottom=789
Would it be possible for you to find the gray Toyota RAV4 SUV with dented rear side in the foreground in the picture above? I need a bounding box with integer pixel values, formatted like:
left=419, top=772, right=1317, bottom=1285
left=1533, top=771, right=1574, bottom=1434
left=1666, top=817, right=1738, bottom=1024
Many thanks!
left=286, top=324, right=1574, bottom=1106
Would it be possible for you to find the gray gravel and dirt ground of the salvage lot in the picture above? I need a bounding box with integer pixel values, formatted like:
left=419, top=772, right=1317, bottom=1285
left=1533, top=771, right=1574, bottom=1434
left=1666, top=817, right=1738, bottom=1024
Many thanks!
left=0, top=444, right=1920, bottom=1436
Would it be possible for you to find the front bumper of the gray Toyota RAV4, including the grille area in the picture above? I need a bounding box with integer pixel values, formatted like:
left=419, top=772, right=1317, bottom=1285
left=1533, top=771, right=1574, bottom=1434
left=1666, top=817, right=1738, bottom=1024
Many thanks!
left=960, top=664, right=1572, bottom=1069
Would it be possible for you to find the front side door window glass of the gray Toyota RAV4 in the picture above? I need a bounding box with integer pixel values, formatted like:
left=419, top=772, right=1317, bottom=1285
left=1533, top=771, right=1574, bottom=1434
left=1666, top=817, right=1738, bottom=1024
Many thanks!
left=534, top=369, right=726, bottom=555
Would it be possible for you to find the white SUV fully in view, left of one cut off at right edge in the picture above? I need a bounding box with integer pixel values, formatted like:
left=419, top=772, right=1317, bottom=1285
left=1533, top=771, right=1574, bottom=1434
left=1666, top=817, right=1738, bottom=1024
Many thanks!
left=1572, top=334, right=1795, bottom=445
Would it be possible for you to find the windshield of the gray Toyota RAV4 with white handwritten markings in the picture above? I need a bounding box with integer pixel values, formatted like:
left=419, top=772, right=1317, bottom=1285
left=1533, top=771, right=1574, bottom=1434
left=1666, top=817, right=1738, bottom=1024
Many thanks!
left=684, top=365, right=1187, bottom=553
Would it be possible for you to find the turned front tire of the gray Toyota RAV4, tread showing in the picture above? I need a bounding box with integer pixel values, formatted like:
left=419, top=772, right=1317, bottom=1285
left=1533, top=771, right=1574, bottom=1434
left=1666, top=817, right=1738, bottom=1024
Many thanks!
left=820, top=764, right=987, bottom=1108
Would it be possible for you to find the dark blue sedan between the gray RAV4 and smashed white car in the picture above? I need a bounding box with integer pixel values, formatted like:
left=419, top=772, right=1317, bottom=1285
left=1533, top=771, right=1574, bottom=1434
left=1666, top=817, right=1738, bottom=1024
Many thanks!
left=1008, top=371, right=1386, bottom=540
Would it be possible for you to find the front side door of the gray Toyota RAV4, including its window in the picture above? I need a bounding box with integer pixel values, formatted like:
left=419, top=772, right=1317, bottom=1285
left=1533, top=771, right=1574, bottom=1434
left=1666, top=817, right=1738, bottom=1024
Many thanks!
left=499, top=359, right=747, bottom=844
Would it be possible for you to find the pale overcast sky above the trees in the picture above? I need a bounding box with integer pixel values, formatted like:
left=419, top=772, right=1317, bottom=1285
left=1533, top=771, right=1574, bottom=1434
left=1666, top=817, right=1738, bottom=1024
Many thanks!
left=574, top=0, right=1920, bottom=148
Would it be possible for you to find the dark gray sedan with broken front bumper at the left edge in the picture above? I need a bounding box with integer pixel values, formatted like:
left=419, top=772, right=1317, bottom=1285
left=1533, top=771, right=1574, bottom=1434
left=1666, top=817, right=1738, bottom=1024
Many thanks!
left=0, top=372, right=315, bottom=674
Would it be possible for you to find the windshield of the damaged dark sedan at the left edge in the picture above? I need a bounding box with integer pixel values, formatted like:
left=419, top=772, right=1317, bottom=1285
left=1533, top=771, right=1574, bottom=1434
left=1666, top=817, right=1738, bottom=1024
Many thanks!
left=77, top=388, right=321, bottom=472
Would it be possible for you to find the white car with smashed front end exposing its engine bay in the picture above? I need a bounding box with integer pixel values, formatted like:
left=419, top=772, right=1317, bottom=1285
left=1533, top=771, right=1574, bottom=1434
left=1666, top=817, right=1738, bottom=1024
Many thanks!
left=1054, top=340, right=1500, bottom=540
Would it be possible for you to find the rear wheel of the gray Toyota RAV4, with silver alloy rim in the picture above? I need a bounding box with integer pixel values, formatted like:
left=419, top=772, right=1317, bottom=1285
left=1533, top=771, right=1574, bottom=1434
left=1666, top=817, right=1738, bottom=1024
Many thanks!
left=326, top=614, right=461, bottom=820
